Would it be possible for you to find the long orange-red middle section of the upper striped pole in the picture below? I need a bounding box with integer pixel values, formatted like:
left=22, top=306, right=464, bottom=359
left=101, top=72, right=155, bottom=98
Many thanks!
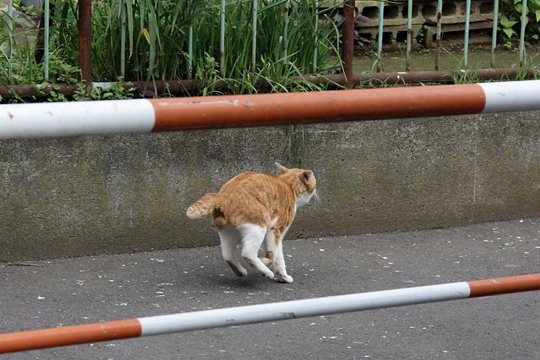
left=149, top=84, right=486, bottom=131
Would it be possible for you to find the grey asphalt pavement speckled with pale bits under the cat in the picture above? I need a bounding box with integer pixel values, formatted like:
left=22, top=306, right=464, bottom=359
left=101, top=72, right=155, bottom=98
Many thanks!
left=0, top=219, right=540, bottom=360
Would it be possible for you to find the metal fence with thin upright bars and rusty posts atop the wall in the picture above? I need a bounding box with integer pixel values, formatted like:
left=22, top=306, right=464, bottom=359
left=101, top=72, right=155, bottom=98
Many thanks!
left=0, top=0, right=533, bottom=98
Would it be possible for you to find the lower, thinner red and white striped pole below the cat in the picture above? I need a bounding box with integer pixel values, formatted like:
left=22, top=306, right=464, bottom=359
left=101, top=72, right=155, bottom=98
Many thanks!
left=0, top=273, right=540, bottom=354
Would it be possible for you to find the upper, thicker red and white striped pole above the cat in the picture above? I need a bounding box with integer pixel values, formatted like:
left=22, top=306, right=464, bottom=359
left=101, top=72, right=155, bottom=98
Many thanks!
left=0, top=80, right=540, bottom=139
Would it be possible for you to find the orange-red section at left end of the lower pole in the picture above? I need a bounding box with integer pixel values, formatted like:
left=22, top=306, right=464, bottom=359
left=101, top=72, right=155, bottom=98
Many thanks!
left=0, top=319, right=142, bottom=354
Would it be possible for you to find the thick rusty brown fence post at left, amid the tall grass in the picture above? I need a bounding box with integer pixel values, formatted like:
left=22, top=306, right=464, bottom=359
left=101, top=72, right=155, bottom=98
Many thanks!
left=79, top=0, right=92, bottom=89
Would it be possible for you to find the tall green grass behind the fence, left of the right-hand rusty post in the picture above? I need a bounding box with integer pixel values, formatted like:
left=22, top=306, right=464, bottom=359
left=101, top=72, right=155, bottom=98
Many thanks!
left=0, top=0, right=339, bottom=95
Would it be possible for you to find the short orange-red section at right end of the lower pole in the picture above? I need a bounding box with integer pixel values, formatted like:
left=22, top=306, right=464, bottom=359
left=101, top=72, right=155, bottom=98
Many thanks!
left=468, top=274, right=540, bottom=297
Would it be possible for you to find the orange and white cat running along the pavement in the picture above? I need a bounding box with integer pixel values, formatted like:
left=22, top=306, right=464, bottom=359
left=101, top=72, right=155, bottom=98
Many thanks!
left=186, top=163, right=316, bottom=283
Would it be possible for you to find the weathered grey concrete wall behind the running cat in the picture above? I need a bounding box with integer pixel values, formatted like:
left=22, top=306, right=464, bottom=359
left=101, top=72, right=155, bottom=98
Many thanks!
left=0, top=112, right=540, bottom=261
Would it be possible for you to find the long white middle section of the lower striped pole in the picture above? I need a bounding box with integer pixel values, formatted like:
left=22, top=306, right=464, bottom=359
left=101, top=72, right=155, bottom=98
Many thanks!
left=138, top=282, right=470, bottom=336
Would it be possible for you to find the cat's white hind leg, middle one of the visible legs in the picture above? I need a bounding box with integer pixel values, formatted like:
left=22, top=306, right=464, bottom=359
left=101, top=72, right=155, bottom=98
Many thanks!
left=238, top=224, right=274, bottom=279
